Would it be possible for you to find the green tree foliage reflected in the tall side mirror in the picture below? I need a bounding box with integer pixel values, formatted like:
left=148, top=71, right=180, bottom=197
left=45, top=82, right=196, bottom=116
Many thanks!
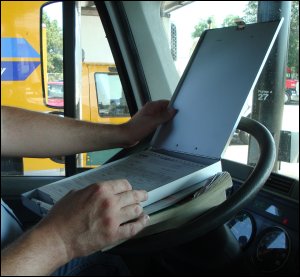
left=42, top=12, right=63, bottom=73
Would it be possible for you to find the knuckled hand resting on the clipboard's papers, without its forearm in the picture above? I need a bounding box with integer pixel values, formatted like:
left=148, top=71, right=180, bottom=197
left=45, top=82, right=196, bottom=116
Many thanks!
left=37, top=180, right=149, bottom=261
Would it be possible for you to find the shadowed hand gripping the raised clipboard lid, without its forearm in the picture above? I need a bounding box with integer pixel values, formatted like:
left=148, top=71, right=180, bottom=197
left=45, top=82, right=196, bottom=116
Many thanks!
left=123, top=100, right=176, bottom=147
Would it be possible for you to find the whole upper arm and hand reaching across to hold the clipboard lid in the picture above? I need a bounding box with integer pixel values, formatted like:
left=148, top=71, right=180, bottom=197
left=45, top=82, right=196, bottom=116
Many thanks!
left=1, top=100, right=175, bottom=158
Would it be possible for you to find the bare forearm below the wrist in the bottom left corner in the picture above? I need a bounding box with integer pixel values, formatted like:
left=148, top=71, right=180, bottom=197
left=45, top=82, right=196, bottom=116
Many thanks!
left=1, top=225, right=68, bottom=276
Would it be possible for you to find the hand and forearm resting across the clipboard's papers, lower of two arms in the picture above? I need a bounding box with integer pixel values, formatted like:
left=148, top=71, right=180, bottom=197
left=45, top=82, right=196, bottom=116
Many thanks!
left=1, top=180, right=149, bottom=276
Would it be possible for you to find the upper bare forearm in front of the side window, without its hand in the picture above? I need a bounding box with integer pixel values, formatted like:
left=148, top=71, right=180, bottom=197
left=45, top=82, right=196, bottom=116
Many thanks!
left=1, top=107, right=127, bottom=157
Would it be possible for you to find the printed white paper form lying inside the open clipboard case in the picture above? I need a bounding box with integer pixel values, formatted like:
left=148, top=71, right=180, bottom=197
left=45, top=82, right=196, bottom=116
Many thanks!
left=39, top=151, right=204, bottom=203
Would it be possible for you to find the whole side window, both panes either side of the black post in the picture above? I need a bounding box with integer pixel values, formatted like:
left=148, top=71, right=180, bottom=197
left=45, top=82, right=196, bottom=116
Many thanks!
left=1, top=1, right=130, bottom=176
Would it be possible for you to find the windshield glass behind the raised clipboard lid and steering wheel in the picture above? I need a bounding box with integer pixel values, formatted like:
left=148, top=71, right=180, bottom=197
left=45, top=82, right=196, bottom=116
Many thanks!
left=161, top=1, right=299, bottom=180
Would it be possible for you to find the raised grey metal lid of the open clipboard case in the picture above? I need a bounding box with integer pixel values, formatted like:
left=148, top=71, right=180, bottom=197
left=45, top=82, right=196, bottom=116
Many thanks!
left=151, top=18, right=283, bottom=164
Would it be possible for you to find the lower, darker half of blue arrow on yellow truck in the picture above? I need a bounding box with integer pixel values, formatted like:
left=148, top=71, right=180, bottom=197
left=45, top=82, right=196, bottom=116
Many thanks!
left=1, top=61, right=40, bottom=82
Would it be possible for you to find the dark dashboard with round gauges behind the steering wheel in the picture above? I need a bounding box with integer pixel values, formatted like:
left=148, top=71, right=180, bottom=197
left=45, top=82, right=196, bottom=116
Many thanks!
left=226, top=180, right=299, bottom=275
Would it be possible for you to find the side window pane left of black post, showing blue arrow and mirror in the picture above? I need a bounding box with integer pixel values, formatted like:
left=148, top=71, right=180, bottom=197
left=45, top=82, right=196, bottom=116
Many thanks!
left=1, top=1, right=65, bottom=176
